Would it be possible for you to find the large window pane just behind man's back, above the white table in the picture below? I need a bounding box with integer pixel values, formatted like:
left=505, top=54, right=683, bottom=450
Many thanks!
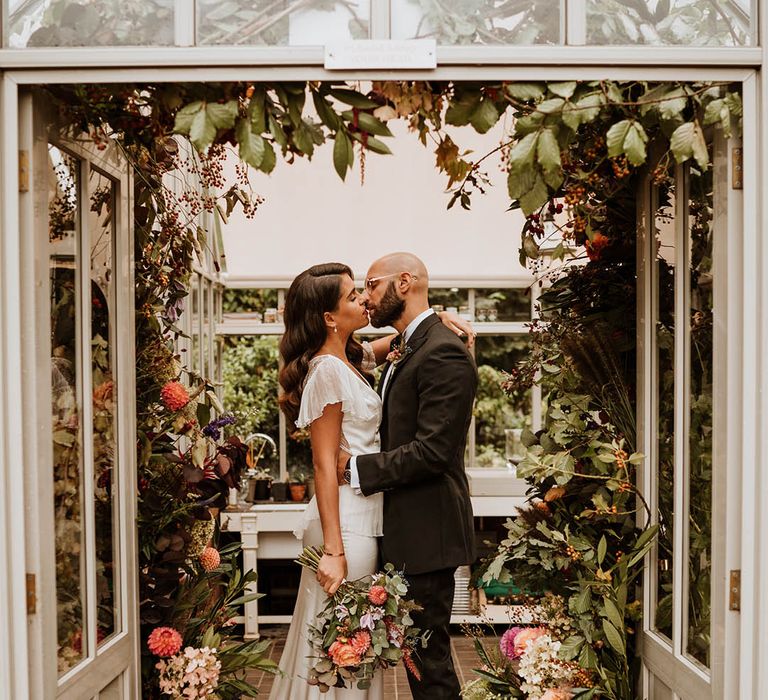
left=474, top=335, right=531, bottom=467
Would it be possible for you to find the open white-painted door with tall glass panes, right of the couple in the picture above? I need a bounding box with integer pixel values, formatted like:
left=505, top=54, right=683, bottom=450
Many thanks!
left=638, top=133, right=741, bottom=700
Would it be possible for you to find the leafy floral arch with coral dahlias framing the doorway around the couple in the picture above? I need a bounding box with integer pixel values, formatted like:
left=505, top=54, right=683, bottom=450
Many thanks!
left=48, top=81, right=742, bottom=700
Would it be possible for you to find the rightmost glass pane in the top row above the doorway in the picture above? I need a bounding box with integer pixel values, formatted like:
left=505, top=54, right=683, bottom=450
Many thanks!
left=587, top=0, right=753, bottom=46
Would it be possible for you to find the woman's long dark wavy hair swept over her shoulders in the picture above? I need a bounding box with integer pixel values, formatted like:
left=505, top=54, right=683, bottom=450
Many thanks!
left=278, top=263, right=364, bottom=430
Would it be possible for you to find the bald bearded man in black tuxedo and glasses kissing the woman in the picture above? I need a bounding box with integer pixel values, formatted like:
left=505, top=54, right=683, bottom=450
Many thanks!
left=339, top=253, right=477, bottom=700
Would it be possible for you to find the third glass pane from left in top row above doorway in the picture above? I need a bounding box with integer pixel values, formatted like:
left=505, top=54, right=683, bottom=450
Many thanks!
left=391, top=0, right=561, bottom=46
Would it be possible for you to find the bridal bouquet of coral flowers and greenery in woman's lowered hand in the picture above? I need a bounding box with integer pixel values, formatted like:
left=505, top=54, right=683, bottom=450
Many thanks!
left=296, top=547, right=428, bottom=693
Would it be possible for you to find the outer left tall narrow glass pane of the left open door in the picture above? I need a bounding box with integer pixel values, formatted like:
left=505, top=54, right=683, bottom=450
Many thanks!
left=48, top=145, right=87, bottom=675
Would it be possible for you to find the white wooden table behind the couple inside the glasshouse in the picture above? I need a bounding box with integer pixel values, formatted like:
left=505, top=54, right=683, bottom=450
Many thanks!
left=220, top=476, right=526, bottom=639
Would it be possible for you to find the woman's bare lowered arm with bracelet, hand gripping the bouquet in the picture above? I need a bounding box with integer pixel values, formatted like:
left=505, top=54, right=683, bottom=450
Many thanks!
left=309, top=403, right=347, bottom=595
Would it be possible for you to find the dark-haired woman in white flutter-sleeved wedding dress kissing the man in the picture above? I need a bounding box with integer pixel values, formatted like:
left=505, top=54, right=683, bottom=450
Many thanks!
left=269, top=263, right=471, bottom=700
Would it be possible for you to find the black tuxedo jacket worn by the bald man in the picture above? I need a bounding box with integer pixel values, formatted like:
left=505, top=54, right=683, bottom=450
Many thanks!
left=356, top=315, right=477, bottom=574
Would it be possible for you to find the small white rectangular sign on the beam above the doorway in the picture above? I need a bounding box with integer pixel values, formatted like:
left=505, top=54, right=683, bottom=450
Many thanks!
left=325, top=39, right=437, bottom=70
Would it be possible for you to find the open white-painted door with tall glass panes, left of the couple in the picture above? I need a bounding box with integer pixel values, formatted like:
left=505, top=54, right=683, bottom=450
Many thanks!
left=19, top=92, right=139, bottom=700
